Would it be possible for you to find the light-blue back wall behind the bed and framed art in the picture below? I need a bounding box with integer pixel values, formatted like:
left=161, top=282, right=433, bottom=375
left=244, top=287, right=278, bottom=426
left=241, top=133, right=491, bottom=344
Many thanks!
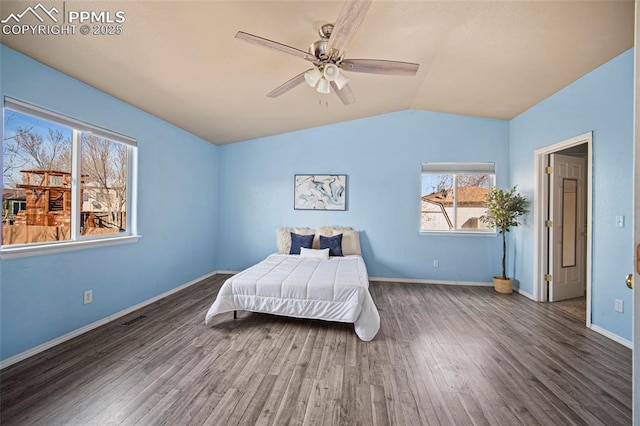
left=218, top=110, right=509, bottom=282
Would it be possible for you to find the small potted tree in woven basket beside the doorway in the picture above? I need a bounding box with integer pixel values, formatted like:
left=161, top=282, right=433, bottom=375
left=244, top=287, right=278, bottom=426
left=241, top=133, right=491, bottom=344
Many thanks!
left=480, top=186, right=527, bottom=294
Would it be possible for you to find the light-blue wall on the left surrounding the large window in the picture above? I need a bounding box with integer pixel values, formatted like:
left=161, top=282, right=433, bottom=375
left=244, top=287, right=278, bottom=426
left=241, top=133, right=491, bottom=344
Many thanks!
left=0, top=46, right=220, bottom=359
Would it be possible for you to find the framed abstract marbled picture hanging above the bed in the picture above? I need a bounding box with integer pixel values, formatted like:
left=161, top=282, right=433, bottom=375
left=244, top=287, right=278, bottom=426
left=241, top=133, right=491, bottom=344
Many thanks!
left=293, top=175, right=347, bottom=210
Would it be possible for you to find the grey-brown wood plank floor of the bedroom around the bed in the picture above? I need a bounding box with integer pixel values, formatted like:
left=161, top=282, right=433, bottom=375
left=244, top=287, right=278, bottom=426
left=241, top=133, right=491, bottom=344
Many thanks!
left=0, top=275, right=631, bottom=425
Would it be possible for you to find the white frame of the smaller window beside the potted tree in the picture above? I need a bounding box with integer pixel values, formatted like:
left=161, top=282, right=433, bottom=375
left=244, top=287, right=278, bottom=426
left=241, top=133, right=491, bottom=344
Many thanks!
left=418, top=162, right=498, bottom=237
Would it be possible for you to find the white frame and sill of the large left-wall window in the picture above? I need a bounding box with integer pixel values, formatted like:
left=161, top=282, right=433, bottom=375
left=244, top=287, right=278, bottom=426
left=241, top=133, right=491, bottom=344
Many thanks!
left=0, top=97, right=140, bottom=260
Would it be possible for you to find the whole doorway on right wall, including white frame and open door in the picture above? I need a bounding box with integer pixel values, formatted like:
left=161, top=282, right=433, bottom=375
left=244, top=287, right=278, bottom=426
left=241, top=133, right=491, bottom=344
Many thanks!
left=533, top=133, right=592, bottom=327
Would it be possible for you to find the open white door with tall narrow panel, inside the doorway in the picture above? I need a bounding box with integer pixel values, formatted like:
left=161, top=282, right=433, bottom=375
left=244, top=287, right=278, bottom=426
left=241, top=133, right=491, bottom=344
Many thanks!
left=549, top=154, right=587, bottom=302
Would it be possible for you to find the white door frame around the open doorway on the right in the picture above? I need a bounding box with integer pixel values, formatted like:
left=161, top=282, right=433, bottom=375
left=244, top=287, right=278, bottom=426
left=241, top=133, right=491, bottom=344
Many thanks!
left=533, top=132, right=593, bottom=327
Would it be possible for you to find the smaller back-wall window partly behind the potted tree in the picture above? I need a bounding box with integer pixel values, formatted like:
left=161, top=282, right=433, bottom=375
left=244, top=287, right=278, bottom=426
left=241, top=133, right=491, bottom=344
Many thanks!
left=420, top=163, right=495, bottom=233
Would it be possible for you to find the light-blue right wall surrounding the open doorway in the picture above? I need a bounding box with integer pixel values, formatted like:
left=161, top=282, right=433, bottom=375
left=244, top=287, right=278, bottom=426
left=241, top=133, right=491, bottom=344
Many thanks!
left=509, top=49, right=633, bottom=340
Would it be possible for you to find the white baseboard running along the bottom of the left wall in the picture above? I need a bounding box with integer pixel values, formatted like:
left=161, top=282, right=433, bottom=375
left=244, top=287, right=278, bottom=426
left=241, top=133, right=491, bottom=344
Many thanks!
left=0, top=271, right=220, bottom=370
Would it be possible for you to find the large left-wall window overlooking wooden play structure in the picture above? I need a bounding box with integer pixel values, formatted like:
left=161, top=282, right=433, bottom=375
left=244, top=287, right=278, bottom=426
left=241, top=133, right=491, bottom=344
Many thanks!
left=2, top=98, right=136, bottom=249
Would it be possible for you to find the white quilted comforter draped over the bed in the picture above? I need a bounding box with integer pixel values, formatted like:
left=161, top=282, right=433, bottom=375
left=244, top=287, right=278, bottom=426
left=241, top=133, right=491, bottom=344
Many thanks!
left=206, top=254, right=380, bottom=341
